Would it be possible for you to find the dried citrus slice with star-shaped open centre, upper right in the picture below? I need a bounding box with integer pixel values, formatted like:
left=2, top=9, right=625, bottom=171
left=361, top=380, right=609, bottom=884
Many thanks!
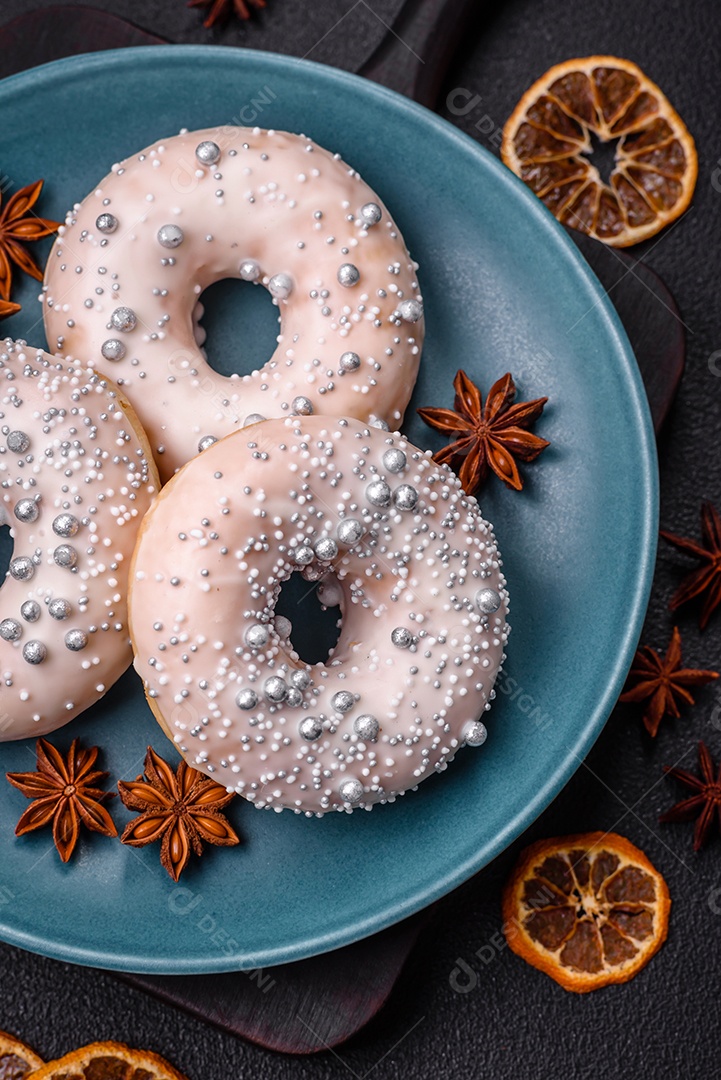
left=501, top=56, right=698, bottom=247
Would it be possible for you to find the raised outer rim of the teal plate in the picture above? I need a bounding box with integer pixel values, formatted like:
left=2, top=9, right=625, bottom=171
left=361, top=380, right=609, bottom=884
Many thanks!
left=0, top=44, right=659, bottom=974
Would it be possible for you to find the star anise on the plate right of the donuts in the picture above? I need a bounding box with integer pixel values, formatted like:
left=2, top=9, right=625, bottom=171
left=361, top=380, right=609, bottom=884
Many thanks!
left=418, top=370, right=550, bottom=495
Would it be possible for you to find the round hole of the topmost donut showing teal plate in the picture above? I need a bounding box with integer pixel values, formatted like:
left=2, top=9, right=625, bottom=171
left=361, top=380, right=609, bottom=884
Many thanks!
left=195, top=278, right=278, bottom=377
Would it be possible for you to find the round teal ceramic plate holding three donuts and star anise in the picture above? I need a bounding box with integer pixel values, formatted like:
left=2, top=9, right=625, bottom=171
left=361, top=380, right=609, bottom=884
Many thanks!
left=0, top=46, right=657, bottom=973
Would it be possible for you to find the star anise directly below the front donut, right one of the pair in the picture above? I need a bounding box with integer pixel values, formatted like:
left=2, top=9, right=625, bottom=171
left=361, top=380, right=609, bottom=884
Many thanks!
left=118, top=746, right=241, bottom=881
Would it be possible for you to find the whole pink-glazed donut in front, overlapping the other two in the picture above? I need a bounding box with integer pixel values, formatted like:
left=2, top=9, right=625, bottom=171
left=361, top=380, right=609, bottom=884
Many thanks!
left=130, top=416, right=508, bottom=814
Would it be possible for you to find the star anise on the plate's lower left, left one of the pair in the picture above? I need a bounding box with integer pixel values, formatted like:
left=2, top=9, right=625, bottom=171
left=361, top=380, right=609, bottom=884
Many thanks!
left=6, top=739, right=118, bottom=863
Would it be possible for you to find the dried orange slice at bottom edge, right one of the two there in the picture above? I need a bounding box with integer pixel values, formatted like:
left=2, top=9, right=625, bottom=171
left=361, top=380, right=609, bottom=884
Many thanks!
left=26, top=1042, right=186, bottom=1080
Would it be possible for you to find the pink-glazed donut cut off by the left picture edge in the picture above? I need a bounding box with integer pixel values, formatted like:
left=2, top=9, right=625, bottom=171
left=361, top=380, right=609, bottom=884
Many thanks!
left=0, top=339, right=159, bottom=741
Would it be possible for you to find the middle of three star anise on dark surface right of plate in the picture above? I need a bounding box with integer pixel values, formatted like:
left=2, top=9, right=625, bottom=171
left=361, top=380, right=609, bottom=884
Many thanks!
left=620, top=626, right=719, bottom=735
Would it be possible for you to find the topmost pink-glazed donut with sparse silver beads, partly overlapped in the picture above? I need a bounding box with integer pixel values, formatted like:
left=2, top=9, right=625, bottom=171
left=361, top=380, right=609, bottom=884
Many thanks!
left=43, top=127, right=423, bottom=481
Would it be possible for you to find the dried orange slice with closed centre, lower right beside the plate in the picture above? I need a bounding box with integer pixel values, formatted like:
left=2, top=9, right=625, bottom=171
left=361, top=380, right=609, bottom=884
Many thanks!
left=503, top=833, right=671, bottom=994
